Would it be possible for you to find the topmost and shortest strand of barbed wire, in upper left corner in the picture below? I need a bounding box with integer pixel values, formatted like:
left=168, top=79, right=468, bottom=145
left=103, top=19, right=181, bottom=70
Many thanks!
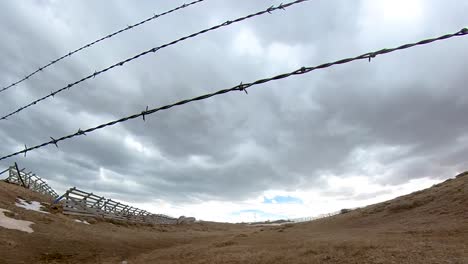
left=0, top=0, right=205, bottom=93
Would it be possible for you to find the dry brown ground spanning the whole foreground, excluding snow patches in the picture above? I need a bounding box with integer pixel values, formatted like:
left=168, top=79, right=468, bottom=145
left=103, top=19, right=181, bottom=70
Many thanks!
left=0, top=171, right=468, bottom=264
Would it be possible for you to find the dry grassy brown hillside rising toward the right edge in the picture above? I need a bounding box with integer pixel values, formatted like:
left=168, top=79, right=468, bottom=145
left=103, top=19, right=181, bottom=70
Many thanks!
left=128, top=173, right=468, bottom=264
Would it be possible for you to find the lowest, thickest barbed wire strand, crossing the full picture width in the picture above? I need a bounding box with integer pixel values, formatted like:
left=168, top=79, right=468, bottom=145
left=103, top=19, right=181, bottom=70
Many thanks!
left=0, top=28, right=468, bottom=160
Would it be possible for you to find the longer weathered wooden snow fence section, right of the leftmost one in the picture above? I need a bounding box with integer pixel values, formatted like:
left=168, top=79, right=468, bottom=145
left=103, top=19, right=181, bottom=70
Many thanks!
left=55, top=187, right=179, bottom=224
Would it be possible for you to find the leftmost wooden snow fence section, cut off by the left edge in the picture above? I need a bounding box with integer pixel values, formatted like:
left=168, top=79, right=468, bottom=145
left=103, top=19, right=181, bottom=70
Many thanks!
left=2, top=163, right=58, bottom=199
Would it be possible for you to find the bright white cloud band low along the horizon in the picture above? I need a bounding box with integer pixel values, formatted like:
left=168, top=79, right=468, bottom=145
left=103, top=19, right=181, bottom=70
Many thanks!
left=133, top=176, right=439, bottom=223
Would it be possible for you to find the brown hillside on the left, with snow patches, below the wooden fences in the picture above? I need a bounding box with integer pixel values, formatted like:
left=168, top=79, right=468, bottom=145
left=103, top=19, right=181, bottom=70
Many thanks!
left=0, top=181, right=247, bottom=264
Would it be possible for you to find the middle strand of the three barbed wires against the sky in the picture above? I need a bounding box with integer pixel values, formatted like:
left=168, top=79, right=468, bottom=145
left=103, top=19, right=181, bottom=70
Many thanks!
left=0, top=0, right=310, bottom=120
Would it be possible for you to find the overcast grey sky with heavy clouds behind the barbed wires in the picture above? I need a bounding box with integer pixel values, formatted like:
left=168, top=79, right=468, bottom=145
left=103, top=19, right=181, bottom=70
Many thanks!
left=0, top=0, right=468, bottom=222
